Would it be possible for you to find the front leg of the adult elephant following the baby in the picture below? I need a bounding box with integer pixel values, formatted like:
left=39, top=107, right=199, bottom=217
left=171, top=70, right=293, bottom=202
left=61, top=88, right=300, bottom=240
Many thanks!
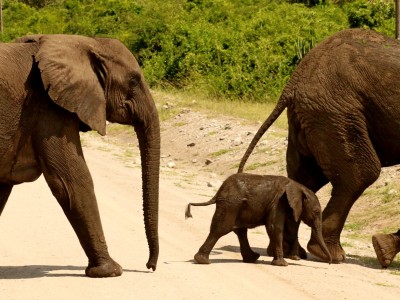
left=35, top=115, right=122, bottom=277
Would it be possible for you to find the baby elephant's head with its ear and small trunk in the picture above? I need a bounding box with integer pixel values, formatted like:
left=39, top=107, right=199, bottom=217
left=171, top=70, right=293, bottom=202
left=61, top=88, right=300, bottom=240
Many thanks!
left=285, top=181, right=332, bottom=263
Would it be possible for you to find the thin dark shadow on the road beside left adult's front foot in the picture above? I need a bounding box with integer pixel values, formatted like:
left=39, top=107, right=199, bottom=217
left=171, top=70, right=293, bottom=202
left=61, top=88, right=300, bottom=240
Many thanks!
left=0, top=265, right=150, bottom=280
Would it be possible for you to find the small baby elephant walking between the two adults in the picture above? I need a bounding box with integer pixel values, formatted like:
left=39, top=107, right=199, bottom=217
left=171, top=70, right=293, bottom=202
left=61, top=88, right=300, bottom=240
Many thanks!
left=185, top=173, right=332, bottom=266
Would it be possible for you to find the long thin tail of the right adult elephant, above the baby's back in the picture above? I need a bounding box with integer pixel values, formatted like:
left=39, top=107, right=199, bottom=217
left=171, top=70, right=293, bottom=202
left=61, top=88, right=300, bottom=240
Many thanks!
left=238, top=91, right=290, bottom=173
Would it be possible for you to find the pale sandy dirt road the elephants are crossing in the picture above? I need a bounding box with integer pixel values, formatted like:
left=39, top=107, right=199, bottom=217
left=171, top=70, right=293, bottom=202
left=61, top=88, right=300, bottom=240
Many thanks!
left=0, top=113, right=400, bottom=300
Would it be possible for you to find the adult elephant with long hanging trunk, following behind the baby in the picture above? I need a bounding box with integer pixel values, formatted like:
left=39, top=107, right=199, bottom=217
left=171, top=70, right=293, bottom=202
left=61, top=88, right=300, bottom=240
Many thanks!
left=0, top=35, right=160, bottom=277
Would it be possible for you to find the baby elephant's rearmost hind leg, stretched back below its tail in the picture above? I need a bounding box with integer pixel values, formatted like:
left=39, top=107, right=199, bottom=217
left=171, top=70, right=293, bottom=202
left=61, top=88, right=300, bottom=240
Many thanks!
left=194, top=203, right=237, bottom=264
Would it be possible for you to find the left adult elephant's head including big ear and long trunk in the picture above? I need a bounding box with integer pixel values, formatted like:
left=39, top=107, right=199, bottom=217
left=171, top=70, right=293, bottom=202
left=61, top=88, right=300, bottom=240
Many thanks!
left=16, top=35, right=160, bottom=270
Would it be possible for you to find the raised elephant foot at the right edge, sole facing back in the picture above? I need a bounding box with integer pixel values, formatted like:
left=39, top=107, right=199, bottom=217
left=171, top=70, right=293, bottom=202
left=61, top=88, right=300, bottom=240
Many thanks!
left=372, top=234, right=400, bottom=268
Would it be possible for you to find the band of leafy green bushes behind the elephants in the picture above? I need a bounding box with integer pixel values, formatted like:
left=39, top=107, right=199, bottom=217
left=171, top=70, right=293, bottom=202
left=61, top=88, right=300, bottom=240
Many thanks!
left=2, top=0, right=394, bottom=103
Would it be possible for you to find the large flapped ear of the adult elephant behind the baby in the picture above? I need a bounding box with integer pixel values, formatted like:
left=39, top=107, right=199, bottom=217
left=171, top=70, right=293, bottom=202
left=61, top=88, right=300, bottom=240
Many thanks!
left=35, top=35, right=106, bottom=135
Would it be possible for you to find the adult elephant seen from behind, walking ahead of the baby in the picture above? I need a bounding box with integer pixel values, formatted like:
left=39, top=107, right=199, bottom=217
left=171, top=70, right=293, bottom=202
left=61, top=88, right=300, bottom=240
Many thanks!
left=239, top=29, right=400, bottom=263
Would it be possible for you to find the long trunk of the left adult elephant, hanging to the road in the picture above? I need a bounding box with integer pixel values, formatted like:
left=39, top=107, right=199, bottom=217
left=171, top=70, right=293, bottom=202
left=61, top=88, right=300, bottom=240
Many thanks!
left=134, top=102, right=160, bottom=271
